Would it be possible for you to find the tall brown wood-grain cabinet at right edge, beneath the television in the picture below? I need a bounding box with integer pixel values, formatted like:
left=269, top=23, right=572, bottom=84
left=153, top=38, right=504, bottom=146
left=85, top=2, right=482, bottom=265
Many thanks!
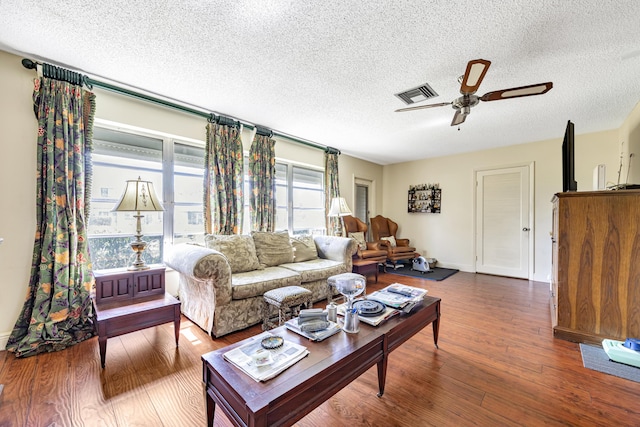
left=551, top=190, right=640, bottom=343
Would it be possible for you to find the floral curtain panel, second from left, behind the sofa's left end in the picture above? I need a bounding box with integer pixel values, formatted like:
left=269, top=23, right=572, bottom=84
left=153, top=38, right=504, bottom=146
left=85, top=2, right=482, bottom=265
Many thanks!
left=204, top=123, right=244, bottom=235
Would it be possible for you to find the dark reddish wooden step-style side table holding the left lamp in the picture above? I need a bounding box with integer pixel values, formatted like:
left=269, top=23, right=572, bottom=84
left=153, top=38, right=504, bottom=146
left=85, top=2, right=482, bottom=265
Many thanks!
left=93, top=267, right=180, bottom=368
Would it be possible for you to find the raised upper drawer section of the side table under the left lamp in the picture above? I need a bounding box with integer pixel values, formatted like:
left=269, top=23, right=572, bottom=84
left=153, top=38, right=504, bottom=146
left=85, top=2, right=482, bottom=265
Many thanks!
left=93, top=267, right=165, bottom=304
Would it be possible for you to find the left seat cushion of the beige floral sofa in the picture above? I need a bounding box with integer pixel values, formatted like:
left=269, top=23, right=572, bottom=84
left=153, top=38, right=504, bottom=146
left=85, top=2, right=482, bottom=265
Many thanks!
left=231, top=267, right=301, bottom=300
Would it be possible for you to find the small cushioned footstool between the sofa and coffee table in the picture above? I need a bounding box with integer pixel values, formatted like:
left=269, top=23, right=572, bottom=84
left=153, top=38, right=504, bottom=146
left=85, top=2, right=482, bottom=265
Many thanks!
left=262, top=286, right=313, bottom=331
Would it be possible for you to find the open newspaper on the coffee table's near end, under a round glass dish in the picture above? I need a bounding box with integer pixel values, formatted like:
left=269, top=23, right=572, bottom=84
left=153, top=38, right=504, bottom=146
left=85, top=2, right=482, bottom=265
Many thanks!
left=224, top=331, right=309, bottom=382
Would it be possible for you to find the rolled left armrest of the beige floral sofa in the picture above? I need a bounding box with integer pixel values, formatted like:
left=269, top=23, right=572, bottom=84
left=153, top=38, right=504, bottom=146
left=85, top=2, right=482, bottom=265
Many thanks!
left=165, top=243, right=231, bottom=305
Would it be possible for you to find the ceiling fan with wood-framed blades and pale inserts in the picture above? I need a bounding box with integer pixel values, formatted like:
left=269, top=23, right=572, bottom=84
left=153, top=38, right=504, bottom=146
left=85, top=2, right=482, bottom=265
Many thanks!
left=396, top=59, right=553, bottom=126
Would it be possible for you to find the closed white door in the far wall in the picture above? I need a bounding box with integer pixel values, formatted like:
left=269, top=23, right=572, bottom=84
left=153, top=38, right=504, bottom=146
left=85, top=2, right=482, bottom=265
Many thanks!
left=476, top=165, right=533, bottom=279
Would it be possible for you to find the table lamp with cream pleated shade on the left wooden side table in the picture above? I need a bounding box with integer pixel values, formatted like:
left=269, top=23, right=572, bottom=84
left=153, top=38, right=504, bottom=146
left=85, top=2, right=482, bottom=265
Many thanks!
left=113, top=177, right=164, bottom=271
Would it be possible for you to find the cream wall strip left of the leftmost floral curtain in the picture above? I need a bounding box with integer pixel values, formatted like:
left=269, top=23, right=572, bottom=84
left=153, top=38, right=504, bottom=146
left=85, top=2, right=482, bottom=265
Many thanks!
left=0, top=51, right=37, bottom=350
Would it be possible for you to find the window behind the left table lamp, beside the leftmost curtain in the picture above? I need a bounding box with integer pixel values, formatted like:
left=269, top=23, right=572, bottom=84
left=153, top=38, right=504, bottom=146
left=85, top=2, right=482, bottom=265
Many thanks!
left=88, top=126, right=204, bottom=270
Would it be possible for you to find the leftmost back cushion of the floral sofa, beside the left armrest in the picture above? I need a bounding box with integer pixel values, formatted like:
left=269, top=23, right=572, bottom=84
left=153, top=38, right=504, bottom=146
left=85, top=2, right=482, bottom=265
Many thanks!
left=204, top=234, right=260, bottom=273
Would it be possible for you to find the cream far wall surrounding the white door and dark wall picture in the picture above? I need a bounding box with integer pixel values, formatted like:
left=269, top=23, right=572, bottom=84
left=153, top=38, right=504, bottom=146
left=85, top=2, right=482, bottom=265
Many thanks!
left=382, top=128, right=618, bottom=281
